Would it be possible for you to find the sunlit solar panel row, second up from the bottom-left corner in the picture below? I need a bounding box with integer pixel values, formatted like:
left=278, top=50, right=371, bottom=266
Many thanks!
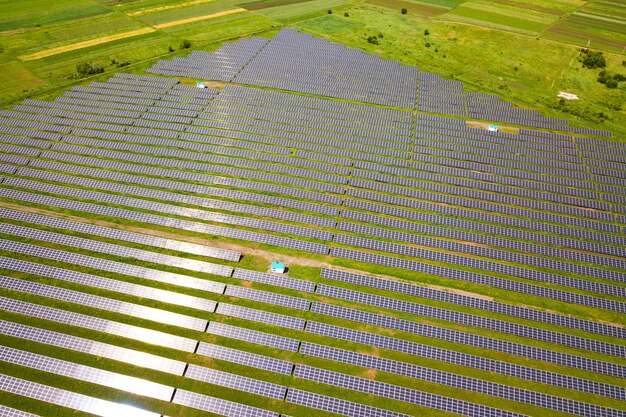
left=0, top=375, right=160, bottom=417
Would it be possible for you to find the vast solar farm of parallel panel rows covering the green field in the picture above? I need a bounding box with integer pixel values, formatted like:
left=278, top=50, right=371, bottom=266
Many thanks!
left=0, top=26, right=626, bottom=416
